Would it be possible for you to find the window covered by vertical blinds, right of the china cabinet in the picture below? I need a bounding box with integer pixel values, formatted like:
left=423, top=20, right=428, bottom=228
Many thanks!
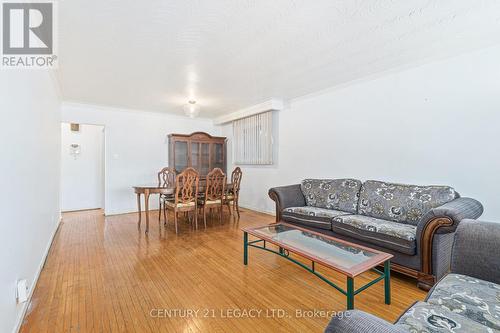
left=233, top=111, right=273, bottom=165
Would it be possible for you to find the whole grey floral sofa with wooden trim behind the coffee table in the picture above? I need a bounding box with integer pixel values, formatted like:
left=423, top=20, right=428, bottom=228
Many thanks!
left=269, top=179, right=483, bottom=290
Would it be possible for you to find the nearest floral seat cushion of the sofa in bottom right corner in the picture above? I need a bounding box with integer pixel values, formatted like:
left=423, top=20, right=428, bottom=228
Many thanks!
left=395, top=302, right=493, bottom=333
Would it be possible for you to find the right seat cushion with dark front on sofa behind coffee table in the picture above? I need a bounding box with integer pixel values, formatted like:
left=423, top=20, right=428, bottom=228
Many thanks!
left=332, top=215, right=417, bottom=255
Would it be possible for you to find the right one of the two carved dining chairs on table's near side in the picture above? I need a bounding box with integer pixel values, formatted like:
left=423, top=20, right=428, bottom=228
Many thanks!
left=198, top=168, right=226, bottom=228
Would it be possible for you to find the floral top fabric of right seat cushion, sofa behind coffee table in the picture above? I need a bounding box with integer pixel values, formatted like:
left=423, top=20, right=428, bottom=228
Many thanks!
left=333, top=215, right=417, bottom=241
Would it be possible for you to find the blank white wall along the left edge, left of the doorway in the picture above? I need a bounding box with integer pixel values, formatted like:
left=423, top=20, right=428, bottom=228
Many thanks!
left=0, top=70, right=60, bottom=332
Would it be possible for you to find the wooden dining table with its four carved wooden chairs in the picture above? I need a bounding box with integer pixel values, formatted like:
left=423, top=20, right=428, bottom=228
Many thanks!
left=133, top=167, right=243, bottom=234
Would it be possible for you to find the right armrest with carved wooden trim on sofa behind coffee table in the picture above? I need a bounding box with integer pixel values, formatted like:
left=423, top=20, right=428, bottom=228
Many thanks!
left=416, top=198, right=483, bottom=285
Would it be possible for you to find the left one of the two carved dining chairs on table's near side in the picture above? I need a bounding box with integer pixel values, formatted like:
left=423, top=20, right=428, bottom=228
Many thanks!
left=164, top=168, right=200, bottom=234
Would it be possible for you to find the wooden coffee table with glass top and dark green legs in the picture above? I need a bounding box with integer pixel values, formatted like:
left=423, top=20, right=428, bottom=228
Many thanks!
left=242, top=222, right=393, bottom=310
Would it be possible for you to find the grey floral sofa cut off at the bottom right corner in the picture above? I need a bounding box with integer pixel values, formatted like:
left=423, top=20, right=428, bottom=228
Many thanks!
left=325, top=220, right=500, bottom=333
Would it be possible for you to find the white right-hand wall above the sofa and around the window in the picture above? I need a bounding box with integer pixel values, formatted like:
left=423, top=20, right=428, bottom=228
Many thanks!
left=221, top=47, right=500, bottom=221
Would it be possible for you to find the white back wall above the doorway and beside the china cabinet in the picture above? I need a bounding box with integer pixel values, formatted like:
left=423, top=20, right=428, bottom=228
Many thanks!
left=61, top=103, right=219, bottom=215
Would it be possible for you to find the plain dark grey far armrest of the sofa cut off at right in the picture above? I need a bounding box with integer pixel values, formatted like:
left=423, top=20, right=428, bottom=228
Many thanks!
left=451, top=220, right=500, bottom=284
